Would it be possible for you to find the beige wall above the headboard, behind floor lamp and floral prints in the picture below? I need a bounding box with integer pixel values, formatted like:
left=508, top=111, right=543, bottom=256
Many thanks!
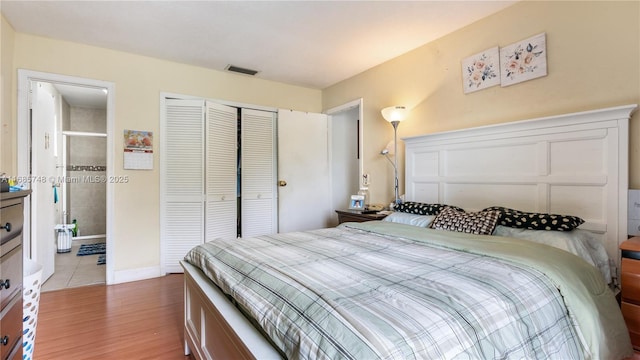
left=323, top=1, right=640, bottom=203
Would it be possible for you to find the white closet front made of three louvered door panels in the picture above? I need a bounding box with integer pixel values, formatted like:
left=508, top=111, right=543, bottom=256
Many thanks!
left=160, top=99, right=278, bottom=273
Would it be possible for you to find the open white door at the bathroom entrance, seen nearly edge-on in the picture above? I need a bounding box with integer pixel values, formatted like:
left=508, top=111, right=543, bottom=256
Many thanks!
left=31, top=82, right=61, bottom=282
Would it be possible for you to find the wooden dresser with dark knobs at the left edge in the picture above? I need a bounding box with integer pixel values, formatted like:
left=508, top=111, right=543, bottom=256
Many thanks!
left=0, top=191, right=31, bottom=360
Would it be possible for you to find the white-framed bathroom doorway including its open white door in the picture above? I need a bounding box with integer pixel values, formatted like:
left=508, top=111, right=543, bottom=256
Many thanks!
left=18, top=71, right=113, bottom=291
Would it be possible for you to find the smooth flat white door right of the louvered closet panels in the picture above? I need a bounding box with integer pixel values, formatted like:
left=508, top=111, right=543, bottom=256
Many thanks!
left=278, top=110, right=332, bottom=233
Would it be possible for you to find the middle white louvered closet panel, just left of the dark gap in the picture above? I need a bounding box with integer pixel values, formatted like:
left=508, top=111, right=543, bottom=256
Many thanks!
left=205, top=102, right=238, bottom=241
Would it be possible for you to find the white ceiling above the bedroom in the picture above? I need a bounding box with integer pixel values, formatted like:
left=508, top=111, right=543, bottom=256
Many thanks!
left=0, top=0, right=515, bottom=93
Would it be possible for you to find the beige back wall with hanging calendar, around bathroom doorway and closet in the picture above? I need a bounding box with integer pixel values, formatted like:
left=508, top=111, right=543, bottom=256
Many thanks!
left=2, top=21, right=321, bottom=279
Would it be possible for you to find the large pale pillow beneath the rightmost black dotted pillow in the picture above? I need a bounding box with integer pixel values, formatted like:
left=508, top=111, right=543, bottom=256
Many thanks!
left=493, top=225, right=612, bottom=284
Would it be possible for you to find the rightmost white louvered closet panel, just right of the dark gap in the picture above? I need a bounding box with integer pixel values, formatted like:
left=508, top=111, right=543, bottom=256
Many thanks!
left=240, top=109, right=278, bottom=237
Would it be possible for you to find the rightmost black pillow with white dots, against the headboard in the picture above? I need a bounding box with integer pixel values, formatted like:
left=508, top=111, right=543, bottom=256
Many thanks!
left=483, top=206, right=584, bottom=231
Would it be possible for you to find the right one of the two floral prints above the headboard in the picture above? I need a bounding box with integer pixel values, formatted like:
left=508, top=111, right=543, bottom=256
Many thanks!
left=500, top=33, right=547, bottom=86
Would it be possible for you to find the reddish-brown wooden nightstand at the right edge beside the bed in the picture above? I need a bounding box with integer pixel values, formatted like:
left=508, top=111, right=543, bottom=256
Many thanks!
left=620, top=237, right=640, bottom=351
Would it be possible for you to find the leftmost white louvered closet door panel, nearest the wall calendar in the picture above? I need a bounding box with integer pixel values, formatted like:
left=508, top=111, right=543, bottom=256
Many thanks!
left=160, top=100, right=204, bottom=273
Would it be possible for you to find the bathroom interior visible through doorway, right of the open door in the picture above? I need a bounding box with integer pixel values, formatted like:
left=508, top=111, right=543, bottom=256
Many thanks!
left=46, top=100, right=107, bottom=291
